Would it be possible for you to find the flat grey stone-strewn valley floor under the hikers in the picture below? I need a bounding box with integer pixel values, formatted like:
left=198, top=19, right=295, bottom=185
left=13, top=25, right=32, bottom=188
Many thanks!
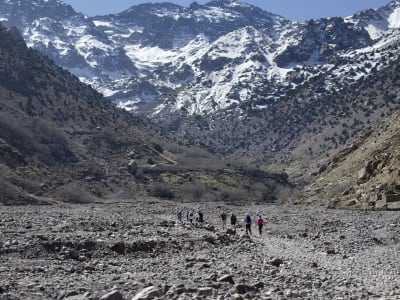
left=0, top=201, right=400, bottom=300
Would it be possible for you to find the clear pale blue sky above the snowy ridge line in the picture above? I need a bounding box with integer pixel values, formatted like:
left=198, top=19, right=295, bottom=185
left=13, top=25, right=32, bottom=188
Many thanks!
left=64, top=0, right=390, bottom=20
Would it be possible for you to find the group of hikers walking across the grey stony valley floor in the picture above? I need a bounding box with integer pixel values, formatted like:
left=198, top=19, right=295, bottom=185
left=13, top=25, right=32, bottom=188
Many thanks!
left=178, top=209, right=264, bottom=235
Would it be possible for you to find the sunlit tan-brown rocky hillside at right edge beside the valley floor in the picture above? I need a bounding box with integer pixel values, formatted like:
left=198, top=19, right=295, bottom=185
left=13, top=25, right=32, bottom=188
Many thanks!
left=299, top=109, right=400, bottom=210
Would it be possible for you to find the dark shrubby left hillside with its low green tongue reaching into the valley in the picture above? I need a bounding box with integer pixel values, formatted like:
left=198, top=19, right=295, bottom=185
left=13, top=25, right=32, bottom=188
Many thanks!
left=0, top=27, right=290, bottom=204
